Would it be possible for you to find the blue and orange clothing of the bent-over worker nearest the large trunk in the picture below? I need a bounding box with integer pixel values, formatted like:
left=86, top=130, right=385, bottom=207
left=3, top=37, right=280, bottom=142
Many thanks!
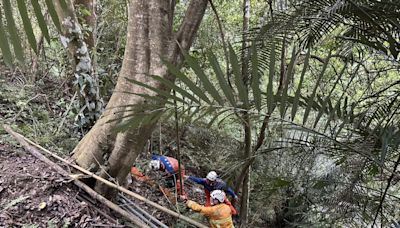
left=151, top=154, right=186, bottom=195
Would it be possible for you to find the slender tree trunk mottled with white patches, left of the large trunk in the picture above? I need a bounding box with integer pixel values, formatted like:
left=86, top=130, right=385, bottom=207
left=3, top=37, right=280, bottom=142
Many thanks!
left=53, top=0, right=103, bottom=130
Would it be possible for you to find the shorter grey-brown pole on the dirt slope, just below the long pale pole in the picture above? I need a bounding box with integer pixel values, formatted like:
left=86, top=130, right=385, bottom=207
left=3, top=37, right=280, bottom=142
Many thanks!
left=4, top=125, right=148, bottom=228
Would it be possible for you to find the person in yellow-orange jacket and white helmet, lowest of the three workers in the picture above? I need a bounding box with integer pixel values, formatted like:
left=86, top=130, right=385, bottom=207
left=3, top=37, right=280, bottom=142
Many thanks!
left=186, top=190, right=234, bottom=228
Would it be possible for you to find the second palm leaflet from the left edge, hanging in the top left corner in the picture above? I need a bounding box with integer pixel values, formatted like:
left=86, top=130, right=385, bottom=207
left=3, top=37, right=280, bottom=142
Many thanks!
left=3, top=0, right=24, bottom=65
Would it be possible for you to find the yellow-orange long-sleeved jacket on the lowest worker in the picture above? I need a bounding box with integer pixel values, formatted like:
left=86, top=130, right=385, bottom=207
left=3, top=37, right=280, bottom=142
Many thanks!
left=186, top=200, right=235, bottom=228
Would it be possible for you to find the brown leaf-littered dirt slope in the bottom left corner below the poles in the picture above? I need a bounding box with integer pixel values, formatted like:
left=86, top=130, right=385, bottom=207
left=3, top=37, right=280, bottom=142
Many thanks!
left=0, top=144, right=124, bottom=227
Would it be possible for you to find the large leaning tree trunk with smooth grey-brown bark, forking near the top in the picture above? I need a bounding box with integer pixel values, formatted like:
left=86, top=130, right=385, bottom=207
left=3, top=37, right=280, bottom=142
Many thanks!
left=73, top=0, right=207, bottom=196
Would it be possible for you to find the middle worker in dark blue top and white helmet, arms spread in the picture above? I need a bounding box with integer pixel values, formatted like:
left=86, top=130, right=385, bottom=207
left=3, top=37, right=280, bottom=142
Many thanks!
left=188, top=171, right=238, bottom=215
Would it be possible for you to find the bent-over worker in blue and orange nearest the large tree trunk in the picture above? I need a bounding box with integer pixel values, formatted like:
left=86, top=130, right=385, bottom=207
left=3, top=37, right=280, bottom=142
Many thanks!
left=149, top=153, right=186, bottom=199
